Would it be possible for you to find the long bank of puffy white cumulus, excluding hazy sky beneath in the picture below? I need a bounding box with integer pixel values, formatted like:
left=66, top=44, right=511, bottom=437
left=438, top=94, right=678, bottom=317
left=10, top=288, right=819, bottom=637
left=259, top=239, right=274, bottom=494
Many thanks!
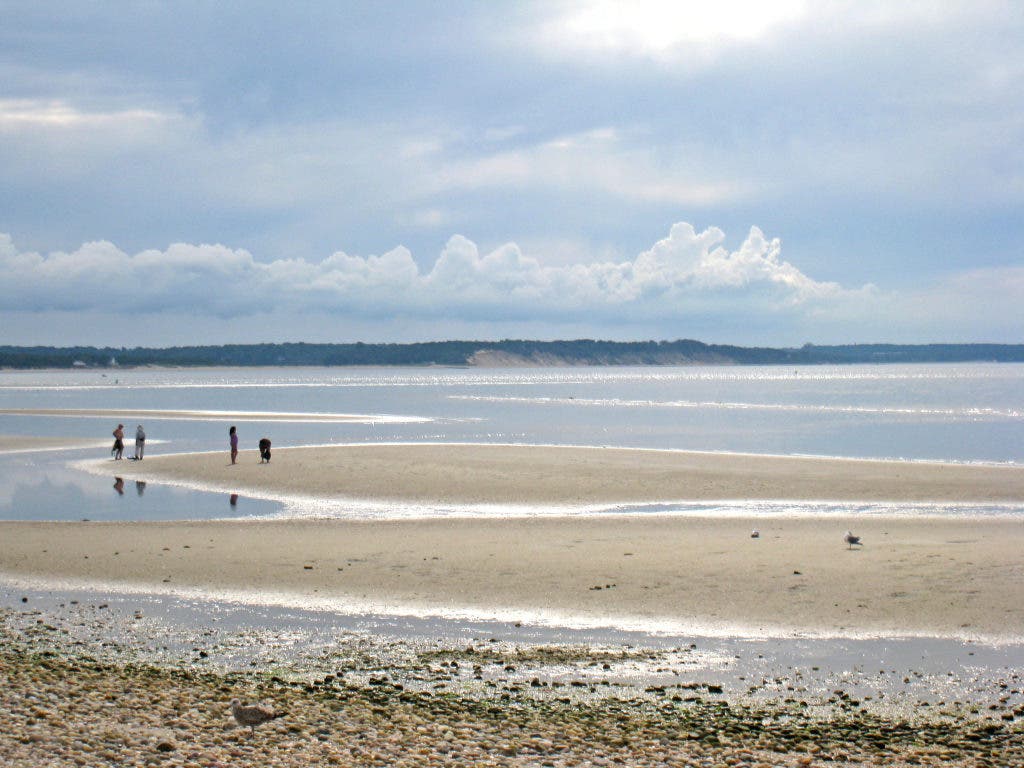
left=0, top=223, right=873, bottom=329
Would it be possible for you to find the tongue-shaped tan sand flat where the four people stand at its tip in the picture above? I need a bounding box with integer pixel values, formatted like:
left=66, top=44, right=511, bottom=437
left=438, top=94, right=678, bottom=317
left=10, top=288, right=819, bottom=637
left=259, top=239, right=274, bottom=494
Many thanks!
left=101, top=443, right=1024, bottom=506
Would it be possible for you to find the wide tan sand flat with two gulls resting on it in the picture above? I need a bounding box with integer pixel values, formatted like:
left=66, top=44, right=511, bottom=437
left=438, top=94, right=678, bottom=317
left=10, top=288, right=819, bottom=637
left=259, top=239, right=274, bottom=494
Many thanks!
left=0, top=515, right=1024, bottom=639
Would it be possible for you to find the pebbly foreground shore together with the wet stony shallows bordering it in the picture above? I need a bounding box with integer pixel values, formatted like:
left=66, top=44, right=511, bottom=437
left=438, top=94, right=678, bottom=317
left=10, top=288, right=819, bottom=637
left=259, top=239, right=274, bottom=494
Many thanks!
left=0, top=584, right=1024, bottom=768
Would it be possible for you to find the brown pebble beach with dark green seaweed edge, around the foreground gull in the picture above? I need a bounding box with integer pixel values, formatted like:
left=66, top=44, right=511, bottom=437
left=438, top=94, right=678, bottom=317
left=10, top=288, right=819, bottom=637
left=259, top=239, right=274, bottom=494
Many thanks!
left=0, top=647, right=1024, bottom=766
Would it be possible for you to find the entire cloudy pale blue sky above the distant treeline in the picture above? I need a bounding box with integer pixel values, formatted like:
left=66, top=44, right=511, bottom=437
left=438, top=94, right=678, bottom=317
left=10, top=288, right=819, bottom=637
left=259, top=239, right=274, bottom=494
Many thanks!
left=0, top=0, right=1024, bottom=346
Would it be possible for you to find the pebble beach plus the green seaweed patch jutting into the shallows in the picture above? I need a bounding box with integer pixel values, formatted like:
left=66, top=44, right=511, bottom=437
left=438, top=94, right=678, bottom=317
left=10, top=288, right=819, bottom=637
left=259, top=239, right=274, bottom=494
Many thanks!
left=0, top=606, right=1024, bottom=768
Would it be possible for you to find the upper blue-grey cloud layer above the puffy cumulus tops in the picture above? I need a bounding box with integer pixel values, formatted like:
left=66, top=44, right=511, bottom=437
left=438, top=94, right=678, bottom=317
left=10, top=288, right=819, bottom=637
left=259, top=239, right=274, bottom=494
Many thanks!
left=0, top=0, right=1024, bottom=284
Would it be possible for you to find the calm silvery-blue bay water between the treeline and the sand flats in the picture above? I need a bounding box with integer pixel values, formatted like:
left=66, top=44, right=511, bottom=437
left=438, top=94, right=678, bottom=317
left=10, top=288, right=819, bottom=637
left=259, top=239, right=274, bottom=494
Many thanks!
left=0, top=364, right=1024, bottom=519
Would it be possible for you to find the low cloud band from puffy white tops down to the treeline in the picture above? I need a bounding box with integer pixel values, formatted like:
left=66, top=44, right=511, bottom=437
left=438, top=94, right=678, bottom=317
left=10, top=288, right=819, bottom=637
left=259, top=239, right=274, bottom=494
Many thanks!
left=0, top=222, right=1024, bottom=345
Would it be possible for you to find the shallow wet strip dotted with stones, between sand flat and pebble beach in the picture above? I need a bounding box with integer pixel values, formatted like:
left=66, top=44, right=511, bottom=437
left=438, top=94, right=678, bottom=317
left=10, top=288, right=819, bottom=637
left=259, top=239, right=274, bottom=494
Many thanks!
left=0, top=580, right=1024, bottom=715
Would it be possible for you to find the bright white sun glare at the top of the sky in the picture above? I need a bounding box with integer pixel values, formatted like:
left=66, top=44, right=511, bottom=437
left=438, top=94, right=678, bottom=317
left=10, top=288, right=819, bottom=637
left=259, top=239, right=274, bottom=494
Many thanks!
left=562, top=0, right=805, bottom=54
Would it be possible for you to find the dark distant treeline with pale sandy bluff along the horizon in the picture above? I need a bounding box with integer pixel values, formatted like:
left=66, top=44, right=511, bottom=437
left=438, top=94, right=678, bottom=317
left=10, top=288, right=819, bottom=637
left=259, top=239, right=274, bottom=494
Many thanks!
left=0, top=339, right=1024, bottom=369
